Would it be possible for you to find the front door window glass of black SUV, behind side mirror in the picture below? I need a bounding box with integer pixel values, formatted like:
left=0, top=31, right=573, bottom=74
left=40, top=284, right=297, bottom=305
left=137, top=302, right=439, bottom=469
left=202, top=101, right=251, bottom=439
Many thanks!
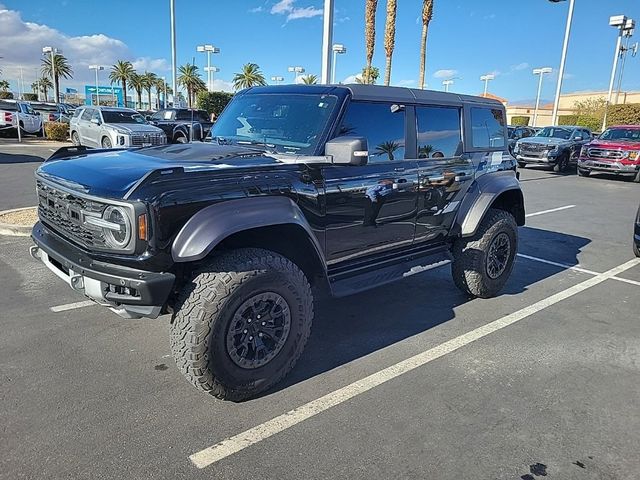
left=338, top=102, right=405, bottom=162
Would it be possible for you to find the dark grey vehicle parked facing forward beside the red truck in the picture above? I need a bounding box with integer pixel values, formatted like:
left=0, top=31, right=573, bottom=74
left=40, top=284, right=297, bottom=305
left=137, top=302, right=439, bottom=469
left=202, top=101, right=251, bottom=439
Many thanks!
left=513, top=126, right=593, bottom=172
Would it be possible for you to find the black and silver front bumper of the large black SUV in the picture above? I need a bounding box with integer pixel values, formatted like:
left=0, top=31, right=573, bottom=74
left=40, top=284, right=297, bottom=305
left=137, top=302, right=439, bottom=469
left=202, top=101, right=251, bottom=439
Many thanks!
left=30, top=222, right=175, bottom=318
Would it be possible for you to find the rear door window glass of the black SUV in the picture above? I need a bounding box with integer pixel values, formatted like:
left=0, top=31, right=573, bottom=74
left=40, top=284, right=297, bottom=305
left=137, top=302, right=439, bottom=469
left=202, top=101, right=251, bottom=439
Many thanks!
left=416, top=107, right=462, bottom=158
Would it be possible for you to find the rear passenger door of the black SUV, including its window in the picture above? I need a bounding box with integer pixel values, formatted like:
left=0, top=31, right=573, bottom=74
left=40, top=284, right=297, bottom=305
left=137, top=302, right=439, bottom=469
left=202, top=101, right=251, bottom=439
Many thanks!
left=415, top=105, right=474, bottom=243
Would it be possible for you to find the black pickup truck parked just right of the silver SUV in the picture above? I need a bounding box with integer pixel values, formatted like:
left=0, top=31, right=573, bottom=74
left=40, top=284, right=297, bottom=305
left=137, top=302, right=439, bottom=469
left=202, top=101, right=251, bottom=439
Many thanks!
left=147, top=108, right=213, bottom=143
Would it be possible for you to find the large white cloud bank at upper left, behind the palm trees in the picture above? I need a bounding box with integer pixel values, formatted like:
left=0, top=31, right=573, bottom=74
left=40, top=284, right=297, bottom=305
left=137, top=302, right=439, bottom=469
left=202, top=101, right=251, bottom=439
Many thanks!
left=0, top=4, right=168, bottom=90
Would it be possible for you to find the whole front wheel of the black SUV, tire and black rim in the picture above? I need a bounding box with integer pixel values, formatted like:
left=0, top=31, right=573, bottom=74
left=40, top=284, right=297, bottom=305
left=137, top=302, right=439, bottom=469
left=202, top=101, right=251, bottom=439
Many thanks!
left=171, top=248, right=313, bottom=401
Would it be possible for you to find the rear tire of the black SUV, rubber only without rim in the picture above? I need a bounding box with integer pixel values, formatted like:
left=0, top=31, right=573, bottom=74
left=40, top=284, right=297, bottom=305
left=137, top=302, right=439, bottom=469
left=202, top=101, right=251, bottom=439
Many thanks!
left=451, top=208, right=518, bottom=298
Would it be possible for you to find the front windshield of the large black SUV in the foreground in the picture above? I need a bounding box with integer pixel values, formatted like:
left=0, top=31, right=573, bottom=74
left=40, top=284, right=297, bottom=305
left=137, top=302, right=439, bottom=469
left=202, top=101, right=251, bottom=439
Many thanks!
left=211, top=94, right=338, bottom=155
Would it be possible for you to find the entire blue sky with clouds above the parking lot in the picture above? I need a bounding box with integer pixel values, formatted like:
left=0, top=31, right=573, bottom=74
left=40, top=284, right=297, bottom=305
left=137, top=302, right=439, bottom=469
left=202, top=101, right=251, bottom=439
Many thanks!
left=0, top=0, right=640, bottom=101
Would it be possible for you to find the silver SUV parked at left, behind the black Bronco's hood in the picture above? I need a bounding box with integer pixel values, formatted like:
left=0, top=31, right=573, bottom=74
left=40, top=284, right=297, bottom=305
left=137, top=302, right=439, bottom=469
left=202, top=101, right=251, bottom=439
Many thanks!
left=69, top=106, right=167, bottom=148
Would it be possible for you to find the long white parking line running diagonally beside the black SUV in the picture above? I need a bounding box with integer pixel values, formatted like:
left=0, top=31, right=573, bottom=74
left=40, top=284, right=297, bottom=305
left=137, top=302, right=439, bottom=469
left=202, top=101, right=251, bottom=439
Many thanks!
left=189, top=258, right=640, bottom=468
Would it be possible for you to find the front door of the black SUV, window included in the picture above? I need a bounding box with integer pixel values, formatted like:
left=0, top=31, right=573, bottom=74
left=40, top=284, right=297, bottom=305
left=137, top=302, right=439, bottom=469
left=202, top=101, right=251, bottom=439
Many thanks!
left=323, top=102, right=418, bottom=265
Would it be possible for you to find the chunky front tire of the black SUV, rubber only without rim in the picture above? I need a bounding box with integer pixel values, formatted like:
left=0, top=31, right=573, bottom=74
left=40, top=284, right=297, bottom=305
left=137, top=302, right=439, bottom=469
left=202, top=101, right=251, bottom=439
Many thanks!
left=171, top=248, right=313, bottom=401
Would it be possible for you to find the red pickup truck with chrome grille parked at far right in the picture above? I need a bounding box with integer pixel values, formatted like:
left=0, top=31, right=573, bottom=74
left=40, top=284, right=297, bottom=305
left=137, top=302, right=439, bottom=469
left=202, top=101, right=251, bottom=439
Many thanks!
left=578, top=125, right=640, bottom=183
